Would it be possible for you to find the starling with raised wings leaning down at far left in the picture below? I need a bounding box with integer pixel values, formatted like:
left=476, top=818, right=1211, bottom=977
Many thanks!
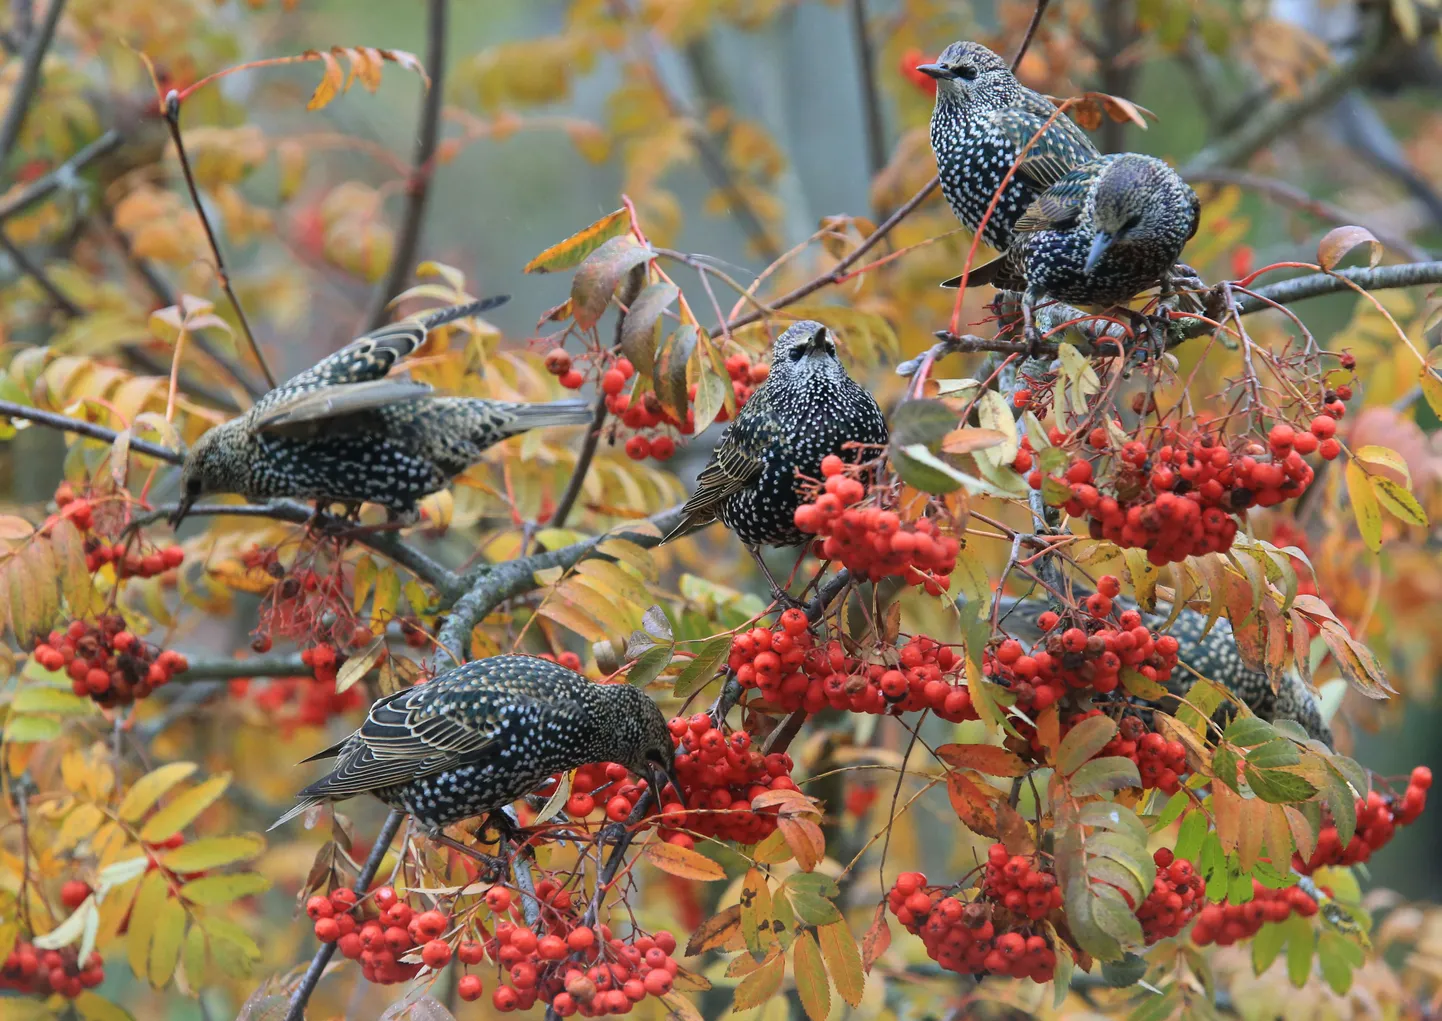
left=172, top=297, right=591, bottom=523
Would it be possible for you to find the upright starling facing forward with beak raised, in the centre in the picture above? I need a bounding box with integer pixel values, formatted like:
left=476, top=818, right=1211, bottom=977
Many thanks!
left=666, top=320, right=890, bottom=555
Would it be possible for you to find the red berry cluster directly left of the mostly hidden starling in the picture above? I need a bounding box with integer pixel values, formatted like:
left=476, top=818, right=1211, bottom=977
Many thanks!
left=982, top=575, right=1181, bottom=712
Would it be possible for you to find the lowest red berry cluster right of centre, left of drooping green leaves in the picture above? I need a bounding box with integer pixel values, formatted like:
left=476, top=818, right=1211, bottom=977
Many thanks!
left=887, top=872, right=1057, bottom=982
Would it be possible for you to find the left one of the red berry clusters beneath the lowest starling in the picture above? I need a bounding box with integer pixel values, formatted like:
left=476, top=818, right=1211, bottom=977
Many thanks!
left=306, top=887, right=455, bottom=985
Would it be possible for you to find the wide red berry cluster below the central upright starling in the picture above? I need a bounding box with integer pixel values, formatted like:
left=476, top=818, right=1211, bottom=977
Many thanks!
left=727, top=609, right=978, bottom=722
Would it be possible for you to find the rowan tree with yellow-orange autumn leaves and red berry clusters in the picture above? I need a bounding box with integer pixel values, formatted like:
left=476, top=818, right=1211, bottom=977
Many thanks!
left=0, top=0, right=1442, bottom=1021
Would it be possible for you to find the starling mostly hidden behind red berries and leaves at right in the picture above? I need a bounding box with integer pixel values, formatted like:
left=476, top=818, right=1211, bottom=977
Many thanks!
left=1001, top=596, right=1332, bottom=747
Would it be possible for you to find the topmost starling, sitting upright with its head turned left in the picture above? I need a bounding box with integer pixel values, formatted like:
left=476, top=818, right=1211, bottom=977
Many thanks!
left=917, top=42, right=1097, bottom=252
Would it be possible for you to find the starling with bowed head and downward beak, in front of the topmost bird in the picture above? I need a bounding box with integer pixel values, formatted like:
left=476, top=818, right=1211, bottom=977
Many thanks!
left=946, top=153, right=1201, bottom=307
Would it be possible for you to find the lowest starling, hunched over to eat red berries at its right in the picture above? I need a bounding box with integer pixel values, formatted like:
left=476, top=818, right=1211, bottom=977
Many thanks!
left=271, top=656, right=679, bottom=831
